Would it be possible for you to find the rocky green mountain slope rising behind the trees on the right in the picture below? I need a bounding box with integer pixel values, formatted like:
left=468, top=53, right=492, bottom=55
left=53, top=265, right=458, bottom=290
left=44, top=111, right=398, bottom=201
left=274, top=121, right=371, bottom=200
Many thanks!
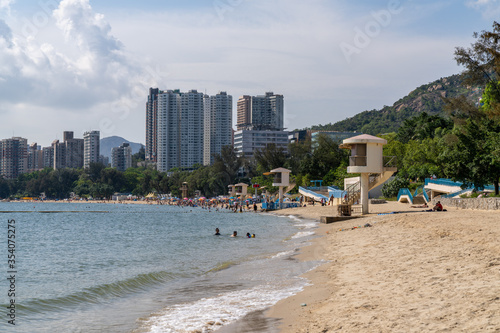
left=309, top=75, right=482, bottom=135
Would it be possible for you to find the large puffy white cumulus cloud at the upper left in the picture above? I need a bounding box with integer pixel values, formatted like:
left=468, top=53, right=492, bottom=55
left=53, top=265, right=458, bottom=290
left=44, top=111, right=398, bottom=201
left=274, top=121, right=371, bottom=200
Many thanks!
left=0, top=0, right=161, bottom=144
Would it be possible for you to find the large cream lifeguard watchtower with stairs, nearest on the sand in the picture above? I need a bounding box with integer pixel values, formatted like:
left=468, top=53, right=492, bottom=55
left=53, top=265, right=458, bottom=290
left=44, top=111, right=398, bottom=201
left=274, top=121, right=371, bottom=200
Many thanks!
left=340, top=134, right=397, bottom=214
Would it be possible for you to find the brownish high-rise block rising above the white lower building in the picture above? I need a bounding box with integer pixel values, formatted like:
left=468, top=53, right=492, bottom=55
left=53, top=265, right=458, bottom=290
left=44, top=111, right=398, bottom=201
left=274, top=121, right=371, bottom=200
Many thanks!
left=236, top=92, right=284, bottom=131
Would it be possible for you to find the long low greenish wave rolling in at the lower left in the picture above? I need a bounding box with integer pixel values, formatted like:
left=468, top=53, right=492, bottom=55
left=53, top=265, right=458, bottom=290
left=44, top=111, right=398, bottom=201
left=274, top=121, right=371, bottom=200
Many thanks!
left=18, top=272, right=178, bottom=314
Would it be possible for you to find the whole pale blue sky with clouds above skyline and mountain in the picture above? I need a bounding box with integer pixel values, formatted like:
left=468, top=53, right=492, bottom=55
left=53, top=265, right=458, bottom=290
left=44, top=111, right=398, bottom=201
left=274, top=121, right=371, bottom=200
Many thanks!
left=0, top=0, right=500, bottom=146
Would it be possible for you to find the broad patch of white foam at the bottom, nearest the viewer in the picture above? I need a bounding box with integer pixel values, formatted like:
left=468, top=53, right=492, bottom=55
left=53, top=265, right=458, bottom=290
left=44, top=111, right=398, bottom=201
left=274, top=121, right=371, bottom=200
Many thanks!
left=145, top=279, right=306, bottom=333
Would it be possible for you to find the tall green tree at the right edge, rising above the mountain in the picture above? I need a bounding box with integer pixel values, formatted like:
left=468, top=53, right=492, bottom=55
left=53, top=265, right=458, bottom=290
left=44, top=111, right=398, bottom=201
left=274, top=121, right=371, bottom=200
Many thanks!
left=445, top=22, right=500, bottom=195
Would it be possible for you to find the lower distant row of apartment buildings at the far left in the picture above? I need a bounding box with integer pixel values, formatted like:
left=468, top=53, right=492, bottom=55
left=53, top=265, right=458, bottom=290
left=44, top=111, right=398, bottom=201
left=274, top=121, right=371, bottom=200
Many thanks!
left=0, top=131, right=102, bottom=179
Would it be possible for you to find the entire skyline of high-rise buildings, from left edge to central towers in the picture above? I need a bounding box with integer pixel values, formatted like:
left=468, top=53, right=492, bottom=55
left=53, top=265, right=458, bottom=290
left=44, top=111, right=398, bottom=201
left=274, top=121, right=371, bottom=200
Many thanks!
left=0, top=88, right=289, bottom=179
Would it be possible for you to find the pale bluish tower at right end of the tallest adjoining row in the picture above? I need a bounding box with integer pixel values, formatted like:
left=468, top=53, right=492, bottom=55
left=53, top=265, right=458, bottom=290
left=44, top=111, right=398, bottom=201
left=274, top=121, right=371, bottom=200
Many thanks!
left=203, top=92, right=233, bottom=165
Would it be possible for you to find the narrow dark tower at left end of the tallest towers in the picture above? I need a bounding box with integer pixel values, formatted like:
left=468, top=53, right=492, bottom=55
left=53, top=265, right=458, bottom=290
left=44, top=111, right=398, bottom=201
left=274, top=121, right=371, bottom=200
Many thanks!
left=145, top=88, right=163, bottom=162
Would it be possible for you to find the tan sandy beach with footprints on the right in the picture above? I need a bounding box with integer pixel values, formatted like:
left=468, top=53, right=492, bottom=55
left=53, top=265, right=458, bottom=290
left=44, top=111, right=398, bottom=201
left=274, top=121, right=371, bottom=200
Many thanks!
left=262, top=203, right=500, bottom=332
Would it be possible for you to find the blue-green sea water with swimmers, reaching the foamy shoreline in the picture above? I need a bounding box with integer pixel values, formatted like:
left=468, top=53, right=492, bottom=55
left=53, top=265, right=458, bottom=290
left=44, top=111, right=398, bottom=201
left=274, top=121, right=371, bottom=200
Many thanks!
left=0, top=203, right=318, bottom=332
